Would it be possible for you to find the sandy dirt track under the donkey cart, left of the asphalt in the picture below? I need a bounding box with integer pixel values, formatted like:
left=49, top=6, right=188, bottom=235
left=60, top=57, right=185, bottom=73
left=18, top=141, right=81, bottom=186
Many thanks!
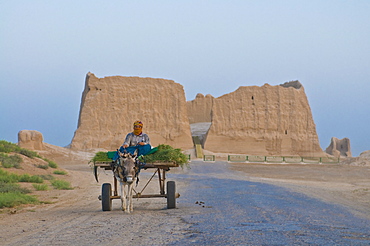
left=0, top=163, right=189, bottom=245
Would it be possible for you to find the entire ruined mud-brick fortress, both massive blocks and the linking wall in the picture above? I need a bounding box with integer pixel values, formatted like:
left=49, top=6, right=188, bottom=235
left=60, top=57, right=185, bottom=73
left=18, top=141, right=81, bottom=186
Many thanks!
left=71, top=73, right=325, bottom=156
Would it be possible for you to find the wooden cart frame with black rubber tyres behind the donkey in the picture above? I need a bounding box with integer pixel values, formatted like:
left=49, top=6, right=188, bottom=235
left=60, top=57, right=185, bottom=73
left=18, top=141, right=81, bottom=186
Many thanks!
left=94, top=156, right=180, bottom=211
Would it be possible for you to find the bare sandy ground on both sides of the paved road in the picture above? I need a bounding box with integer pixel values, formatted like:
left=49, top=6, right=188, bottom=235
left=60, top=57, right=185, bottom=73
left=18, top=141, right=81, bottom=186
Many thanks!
left=0, top=145, right=370, bottom=245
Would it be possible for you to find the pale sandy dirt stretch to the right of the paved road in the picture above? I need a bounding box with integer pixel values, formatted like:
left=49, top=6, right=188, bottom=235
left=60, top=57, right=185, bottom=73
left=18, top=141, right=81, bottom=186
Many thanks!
left=231, top=163, right=370, bottom=219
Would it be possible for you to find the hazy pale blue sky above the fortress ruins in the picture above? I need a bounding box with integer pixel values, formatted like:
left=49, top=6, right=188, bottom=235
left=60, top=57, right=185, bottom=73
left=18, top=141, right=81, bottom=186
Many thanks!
left=0, top=0, right=370, bottom=156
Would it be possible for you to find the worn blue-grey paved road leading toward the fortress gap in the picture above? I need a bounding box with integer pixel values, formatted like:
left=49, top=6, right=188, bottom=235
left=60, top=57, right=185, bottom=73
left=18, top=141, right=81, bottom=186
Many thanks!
left=171, top=161, right=370, bottom=245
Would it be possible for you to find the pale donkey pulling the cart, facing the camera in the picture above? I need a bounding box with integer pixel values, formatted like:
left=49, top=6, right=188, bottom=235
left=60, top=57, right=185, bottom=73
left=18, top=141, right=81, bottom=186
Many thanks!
left=113, top=152, right=138, bottom=213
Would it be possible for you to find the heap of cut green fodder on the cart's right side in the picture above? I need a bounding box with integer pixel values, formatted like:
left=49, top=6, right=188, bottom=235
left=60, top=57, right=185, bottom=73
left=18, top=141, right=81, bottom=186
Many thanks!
left=143, top=144, right=189, bottom=167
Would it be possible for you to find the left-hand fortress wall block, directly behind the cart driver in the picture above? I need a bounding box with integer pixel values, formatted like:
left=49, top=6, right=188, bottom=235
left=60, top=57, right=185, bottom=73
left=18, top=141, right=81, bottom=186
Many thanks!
left=71, top=73, right=193, bottom=150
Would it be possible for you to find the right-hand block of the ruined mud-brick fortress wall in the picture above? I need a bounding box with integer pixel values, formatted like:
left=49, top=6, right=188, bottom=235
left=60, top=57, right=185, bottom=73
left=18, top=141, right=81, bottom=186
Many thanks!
left=204, top=81, right=324, bottom=156
